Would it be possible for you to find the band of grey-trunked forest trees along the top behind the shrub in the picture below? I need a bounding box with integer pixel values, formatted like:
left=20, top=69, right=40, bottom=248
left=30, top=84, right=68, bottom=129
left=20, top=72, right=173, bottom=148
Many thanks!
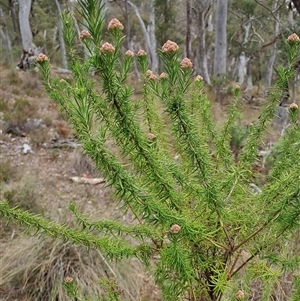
left=0, top=0, right=300, bottom=91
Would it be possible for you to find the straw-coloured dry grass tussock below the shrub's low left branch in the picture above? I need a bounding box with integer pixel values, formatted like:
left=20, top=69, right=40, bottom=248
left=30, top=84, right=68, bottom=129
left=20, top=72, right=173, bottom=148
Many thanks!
left=0, top=236, right=155, bottom=301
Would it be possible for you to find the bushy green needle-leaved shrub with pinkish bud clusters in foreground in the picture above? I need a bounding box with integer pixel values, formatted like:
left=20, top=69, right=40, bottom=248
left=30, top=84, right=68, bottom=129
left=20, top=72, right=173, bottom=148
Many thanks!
left=0, top=0, right=300, bottom=301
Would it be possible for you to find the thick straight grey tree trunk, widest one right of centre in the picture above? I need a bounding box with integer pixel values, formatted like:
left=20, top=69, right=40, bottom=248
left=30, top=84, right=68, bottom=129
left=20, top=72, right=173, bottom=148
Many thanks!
left=214, top=0, right=228, bottom=77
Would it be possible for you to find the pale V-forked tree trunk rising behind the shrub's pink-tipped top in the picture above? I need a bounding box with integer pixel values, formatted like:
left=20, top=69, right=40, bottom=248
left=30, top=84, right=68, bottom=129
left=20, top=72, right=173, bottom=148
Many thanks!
left=128, top=0, right=158, bottom=72
